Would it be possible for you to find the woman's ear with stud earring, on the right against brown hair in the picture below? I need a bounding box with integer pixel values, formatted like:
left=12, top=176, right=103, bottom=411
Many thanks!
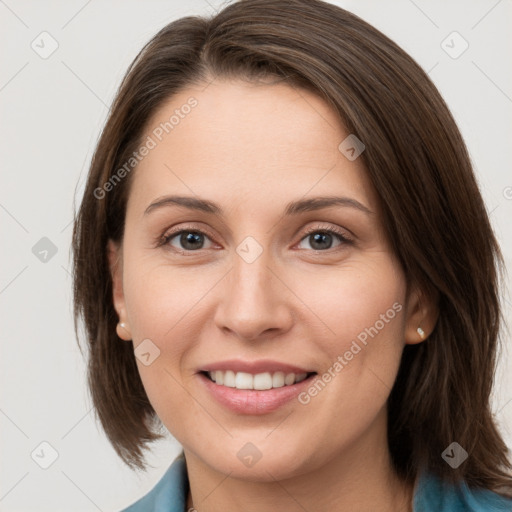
left=405, top=284, right=439, bottom=345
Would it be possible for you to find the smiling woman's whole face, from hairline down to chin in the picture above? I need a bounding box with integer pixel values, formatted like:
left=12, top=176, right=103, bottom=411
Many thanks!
left=110, top=80, right=421, bottom=481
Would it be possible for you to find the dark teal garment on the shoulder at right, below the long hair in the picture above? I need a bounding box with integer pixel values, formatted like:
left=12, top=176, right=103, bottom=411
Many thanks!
left=414, top=472, right=512, bottom=512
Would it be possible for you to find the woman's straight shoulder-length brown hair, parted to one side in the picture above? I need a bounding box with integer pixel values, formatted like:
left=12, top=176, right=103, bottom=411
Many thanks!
left=73, top=0, right=512, bottom=492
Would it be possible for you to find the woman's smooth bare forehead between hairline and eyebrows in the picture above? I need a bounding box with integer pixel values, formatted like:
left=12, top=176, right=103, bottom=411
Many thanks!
left=129, top=77, right=376, bottom=216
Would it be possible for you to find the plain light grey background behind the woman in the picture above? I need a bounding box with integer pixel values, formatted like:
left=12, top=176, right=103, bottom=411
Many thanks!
left=0, top=0, right=512, bottom=512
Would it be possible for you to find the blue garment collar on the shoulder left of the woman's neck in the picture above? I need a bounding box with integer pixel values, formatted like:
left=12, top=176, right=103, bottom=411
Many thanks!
left=121, top=451, right=189, bottom=512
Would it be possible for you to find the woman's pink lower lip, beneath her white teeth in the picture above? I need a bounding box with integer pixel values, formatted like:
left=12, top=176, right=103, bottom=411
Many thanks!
left=198, top=373, right=316, bottom=415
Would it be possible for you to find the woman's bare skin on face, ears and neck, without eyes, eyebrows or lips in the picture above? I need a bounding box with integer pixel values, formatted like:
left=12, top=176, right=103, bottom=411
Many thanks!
left=109, top=79, right=436, bottom=512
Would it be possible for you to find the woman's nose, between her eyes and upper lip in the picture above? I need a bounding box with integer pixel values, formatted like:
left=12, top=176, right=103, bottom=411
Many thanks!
left=215, top=250, right=293, bottom=341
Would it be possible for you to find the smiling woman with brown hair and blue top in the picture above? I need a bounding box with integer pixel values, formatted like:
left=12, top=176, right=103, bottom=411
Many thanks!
left=73, top=0, right=512, bottom=512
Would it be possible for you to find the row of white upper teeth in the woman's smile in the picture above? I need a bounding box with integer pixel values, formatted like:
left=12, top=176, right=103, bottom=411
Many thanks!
left=208, top=370, right=308, bottom=391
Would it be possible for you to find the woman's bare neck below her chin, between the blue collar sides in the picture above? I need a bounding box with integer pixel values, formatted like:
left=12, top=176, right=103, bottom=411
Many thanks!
left=184, top=412, right=413, bottom=512
